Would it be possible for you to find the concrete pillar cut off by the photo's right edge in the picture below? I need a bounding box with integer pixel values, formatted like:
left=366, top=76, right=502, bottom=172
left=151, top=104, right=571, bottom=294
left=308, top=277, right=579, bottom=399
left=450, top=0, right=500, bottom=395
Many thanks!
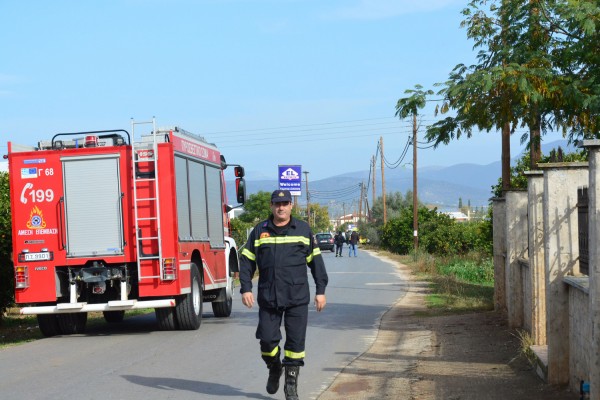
left=583, top=139, right=600, bottom=399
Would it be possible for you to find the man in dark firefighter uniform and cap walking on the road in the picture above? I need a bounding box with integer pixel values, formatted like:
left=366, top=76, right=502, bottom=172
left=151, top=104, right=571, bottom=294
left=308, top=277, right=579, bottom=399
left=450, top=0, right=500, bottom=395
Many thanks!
left=240, top=190, right=328, bottom=400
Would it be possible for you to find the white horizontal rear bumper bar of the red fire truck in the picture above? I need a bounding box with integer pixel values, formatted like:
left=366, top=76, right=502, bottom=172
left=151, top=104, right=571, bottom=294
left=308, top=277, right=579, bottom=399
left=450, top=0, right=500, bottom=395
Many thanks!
left=20, top=299, right=175, bottom=315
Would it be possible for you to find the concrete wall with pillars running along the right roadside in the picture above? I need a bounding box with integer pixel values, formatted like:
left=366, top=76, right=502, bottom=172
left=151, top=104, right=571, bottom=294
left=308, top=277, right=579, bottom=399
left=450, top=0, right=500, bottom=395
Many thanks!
left=493, top=158, right=600, bottom=392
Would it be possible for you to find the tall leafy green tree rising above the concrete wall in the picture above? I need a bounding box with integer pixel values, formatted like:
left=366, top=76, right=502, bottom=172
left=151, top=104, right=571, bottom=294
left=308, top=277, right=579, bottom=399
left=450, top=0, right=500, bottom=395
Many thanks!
left=426, top=0, right=592, bottom=190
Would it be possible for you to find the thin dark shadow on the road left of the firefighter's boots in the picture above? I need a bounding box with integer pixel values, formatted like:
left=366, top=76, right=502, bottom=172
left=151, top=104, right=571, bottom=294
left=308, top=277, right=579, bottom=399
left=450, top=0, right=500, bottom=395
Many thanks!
left=122, top=375, right=271, bottom=400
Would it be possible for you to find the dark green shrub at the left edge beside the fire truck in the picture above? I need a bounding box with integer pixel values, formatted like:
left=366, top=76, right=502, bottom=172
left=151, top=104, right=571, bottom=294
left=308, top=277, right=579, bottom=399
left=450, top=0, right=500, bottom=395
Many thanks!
left=0, top=172, right=14, bottom=319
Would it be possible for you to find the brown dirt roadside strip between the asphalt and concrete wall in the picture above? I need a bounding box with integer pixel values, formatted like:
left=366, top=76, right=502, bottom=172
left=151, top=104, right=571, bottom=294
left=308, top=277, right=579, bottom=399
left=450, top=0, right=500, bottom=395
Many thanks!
left=319, top=254, right=579, bottom=400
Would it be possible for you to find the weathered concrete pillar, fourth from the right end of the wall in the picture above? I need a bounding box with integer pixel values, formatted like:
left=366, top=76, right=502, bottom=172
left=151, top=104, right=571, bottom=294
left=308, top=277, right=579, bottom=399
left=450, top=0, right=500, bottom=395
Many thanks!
left=504, top=190, right=528, bottom=328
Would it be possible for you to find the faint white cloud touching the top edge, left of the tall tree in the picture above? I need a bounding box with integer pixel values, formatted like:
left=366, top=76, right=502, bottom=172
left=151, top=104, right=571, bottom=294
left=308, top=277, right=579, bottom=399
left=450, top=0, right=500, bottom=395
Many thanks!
left=327, top=0, right=464, bottom=20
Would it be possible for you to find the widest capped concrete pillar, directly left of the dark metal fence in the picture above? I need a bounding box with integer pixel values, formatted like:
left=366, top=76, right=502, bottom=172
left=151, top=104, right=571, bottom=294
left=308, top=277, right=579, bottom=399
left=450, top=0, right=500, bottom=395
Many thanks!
left=538, top=162, right=588, bottom=385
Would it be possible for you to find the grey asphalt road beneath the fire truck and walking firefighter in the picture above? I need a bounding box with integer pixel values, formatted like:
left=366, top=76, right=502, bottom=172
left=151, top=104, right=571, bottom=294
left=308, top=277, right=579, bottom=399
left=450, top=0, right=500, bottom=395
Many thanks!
left=0, top=250, right=404, bottom=400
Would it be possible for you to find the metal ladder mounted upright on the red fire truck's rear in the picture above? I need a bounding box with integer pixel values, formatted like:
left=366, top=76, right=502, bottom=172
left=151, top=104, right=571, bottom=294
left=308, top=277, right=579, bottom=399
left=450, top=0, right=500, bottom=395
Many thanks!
left=131, top=118, right=163, bottom=281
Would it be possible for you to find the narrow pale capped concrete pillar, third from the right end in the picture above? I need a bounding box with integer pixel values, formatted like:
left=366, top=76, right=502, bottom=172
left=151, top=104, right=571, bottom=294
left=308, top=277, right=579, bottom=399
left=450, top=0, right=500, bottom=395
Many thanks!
left=525, top=171, right=546, bottom=345
